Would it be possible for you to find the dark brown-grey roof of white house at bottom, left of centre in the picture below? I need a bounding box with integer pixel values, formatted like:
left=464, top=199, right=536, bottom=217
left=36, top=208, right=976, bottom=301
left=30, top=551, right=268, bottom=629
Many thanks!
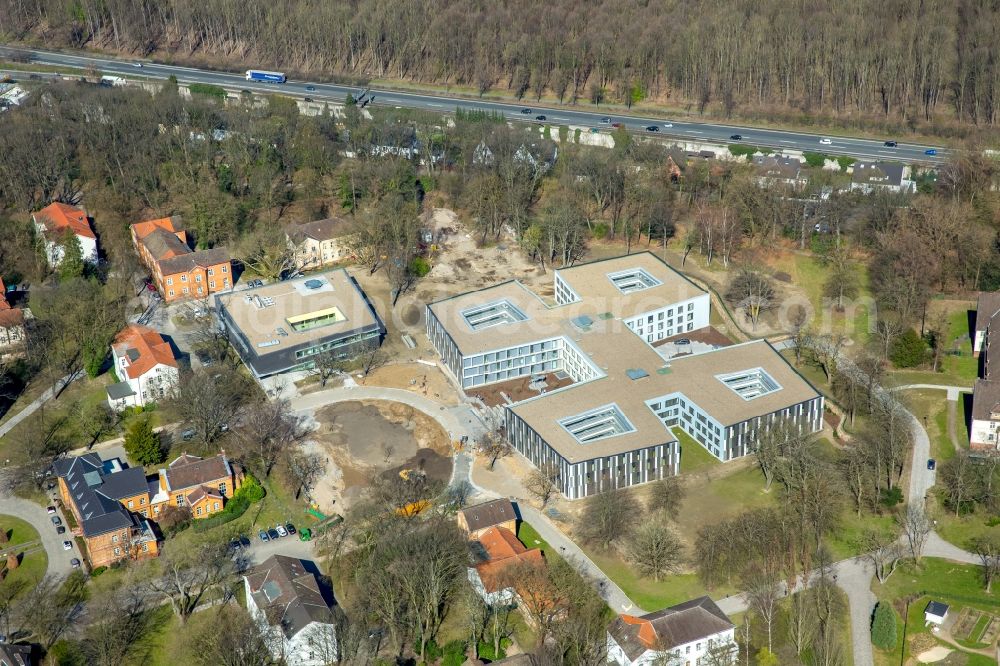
left=245, top=555, right=334, bottom=638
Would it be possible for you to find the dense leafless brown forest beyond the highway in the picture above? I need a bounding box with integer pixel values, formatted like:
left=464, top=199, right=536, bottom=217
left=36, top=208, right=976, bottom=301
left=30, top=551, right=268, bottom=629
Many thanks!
left=0, top=0, right=1000, bottom=130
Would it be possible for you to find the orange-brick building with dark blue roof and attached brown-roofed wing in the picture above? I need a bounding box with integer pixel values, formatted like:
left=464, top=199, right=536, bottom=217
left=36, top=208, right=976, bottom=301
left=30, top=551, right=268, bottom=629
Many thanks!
left=53, top=453, right=243, bottom=567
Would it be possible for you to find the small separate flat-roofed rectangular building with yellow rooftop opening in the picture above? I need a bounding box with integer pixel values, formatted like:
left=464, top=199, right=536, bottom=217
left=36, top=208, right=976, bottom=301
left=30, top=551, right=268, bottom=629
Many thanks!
left=215, top=269, right=385, bottom=378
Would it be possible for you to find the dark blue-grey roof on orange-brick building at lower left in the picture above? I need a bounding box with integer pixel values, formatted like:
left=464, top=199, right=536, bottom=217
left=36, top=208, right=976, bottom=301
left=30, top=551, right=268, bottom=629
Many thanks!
left=52, top=453, right=146, bottom=537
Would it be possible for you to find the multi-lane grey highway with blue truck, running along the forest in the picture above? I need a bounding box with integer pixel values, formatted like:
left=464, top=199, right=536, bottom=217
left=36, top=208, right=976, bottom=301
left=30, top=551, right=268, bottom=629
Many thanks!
left=16, top=49, right=948, bottom=164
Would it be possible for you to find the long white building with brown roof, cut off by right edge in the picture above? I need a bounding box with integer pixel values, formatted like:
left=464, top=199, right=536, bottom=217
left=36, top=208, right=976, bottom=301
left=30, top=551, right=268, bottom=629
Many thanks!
left=969, top=292, right=1000, bottom=453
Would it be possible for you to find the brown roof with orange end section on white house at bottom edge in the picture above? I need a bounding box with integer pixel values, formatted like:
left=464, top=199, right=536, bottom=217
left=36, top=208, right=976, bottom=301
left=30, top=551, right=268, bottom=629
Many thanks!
left=608, top=597, right=733, bottom=661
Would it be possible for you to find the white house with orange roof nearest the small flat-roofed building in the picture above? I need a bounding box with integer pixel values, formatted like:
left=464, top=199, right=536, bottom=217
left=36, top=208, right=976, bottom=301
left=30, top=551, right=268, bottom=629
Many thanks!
left=107, top=324, right=179, bottom=410
